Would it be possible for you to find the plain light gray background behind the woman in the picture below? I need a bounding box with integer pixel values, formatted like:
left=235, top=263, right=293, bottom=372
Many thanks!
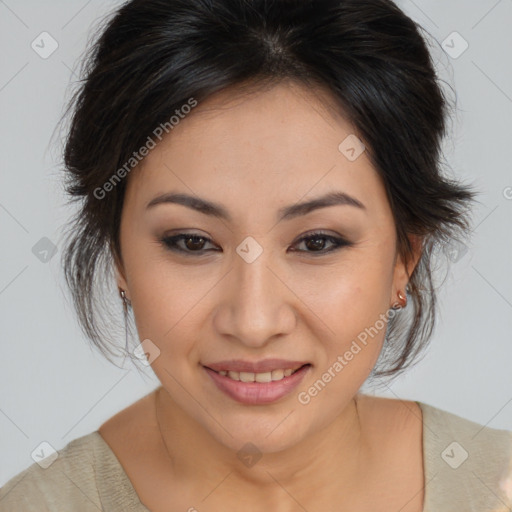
left=0, top=0, right=512, bottom=485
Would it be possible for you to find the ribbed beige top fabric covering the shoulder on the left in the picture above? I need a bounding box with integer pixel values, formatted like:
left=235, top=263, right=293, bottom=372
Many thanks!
left=0, top=431, right=147, bottom=512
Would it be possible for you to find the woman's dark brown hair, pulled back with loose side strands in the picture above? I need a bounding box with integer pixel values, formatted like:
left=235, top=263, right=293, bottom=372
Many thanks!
left=58, top=0, right=475, bottom=376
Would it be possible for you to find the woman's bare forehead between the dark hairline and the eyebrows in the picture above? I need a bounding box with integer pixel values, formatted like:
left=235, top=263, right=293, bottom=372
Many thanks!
left=127, top=83, right=382, bottom=221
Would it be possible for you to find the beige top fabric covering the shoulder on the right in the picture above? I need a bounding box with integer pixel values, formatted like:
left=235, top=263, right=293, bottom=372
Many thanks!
left=417, top=402, right=512, bottom=512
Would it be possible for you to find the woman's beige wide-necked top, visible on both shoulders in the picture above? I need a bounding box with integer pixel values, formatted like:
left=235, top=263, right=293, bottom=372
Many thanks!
left=0, top=402, right=512, bottom=512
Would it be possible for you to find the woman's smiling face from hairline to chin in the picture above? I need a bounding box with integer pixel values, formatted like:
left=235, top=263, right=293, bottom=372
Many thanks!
left=118, top=84, right=416, bottom=452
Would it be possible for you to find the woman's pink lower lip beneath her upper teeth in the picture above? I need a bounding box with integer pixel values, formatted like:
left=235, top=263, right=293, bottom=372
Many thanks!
left=203, top=365, right=310, bottom=405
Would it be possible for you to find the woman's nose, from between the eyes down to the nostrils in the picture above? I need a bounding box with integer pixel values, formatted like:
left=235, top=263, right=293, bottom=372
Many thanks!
left=214, top=247, right=296, bottom=348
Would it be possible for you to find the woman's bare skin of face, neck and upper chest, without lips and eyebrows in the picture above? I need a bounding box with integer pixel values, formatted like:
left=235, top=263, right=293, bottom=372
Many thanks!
left=100, top=83, right=423, bottom=512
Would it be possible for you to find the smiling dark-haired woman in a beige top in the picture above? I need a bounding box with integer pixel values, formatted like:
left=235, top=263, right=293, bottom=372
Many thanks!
left=0, top=0, right=512, bottom=512
